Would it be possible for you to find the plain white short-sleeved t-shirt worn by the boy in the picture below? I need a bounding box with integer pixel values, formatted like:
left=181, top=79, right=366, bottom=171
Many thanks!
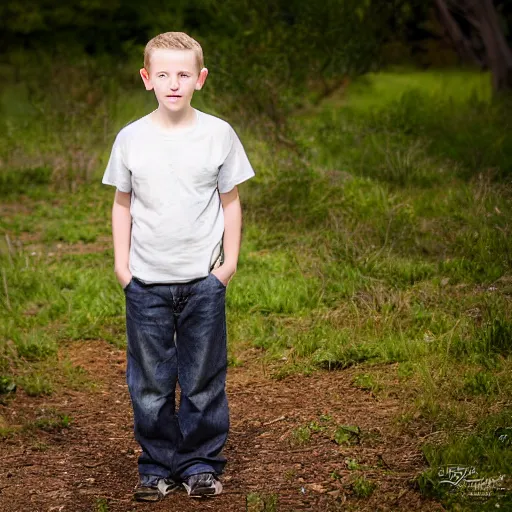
left=102, top=109, right=254, bottom=283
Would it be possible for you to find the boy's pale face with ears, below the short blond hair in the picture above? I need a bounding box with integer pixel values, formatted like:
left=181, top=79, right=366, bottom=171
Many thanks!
left=140, top=48, right=208, bottom=112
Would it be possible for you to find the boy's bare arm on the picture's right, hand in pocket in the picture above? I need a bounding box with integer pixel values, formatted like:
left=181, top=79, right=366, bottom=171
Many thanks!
left=212, top=187, right=242, bottom=286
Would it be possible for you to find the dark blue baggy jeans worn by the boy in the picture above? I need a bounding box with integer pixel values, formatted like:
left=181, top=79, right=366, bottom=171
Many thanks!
left=124, top=273, right=229, bottom=483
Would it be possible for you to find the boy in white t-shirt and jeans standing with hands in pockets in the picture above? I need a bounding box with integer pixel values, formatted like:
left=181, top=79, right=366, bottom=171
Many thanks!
left=103, top=32, right=254, bottom=501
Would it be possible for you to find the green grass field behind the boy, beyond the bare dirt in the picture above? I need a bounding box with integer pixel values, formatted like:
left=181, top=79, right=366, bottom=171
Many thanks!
left=0, top=67, right=512, bottom=510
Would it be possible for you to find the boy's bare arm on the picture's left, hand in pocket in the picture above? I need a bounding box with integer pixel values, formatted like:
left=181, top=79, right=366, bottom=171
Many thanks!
left=112, top=190, right=132, bottom=288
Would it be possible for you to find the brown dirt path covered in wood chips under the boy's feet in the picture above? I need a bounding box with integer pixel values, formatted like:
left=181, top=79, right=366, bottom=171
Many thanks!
left=0, top=341, right=444, bottom=512
